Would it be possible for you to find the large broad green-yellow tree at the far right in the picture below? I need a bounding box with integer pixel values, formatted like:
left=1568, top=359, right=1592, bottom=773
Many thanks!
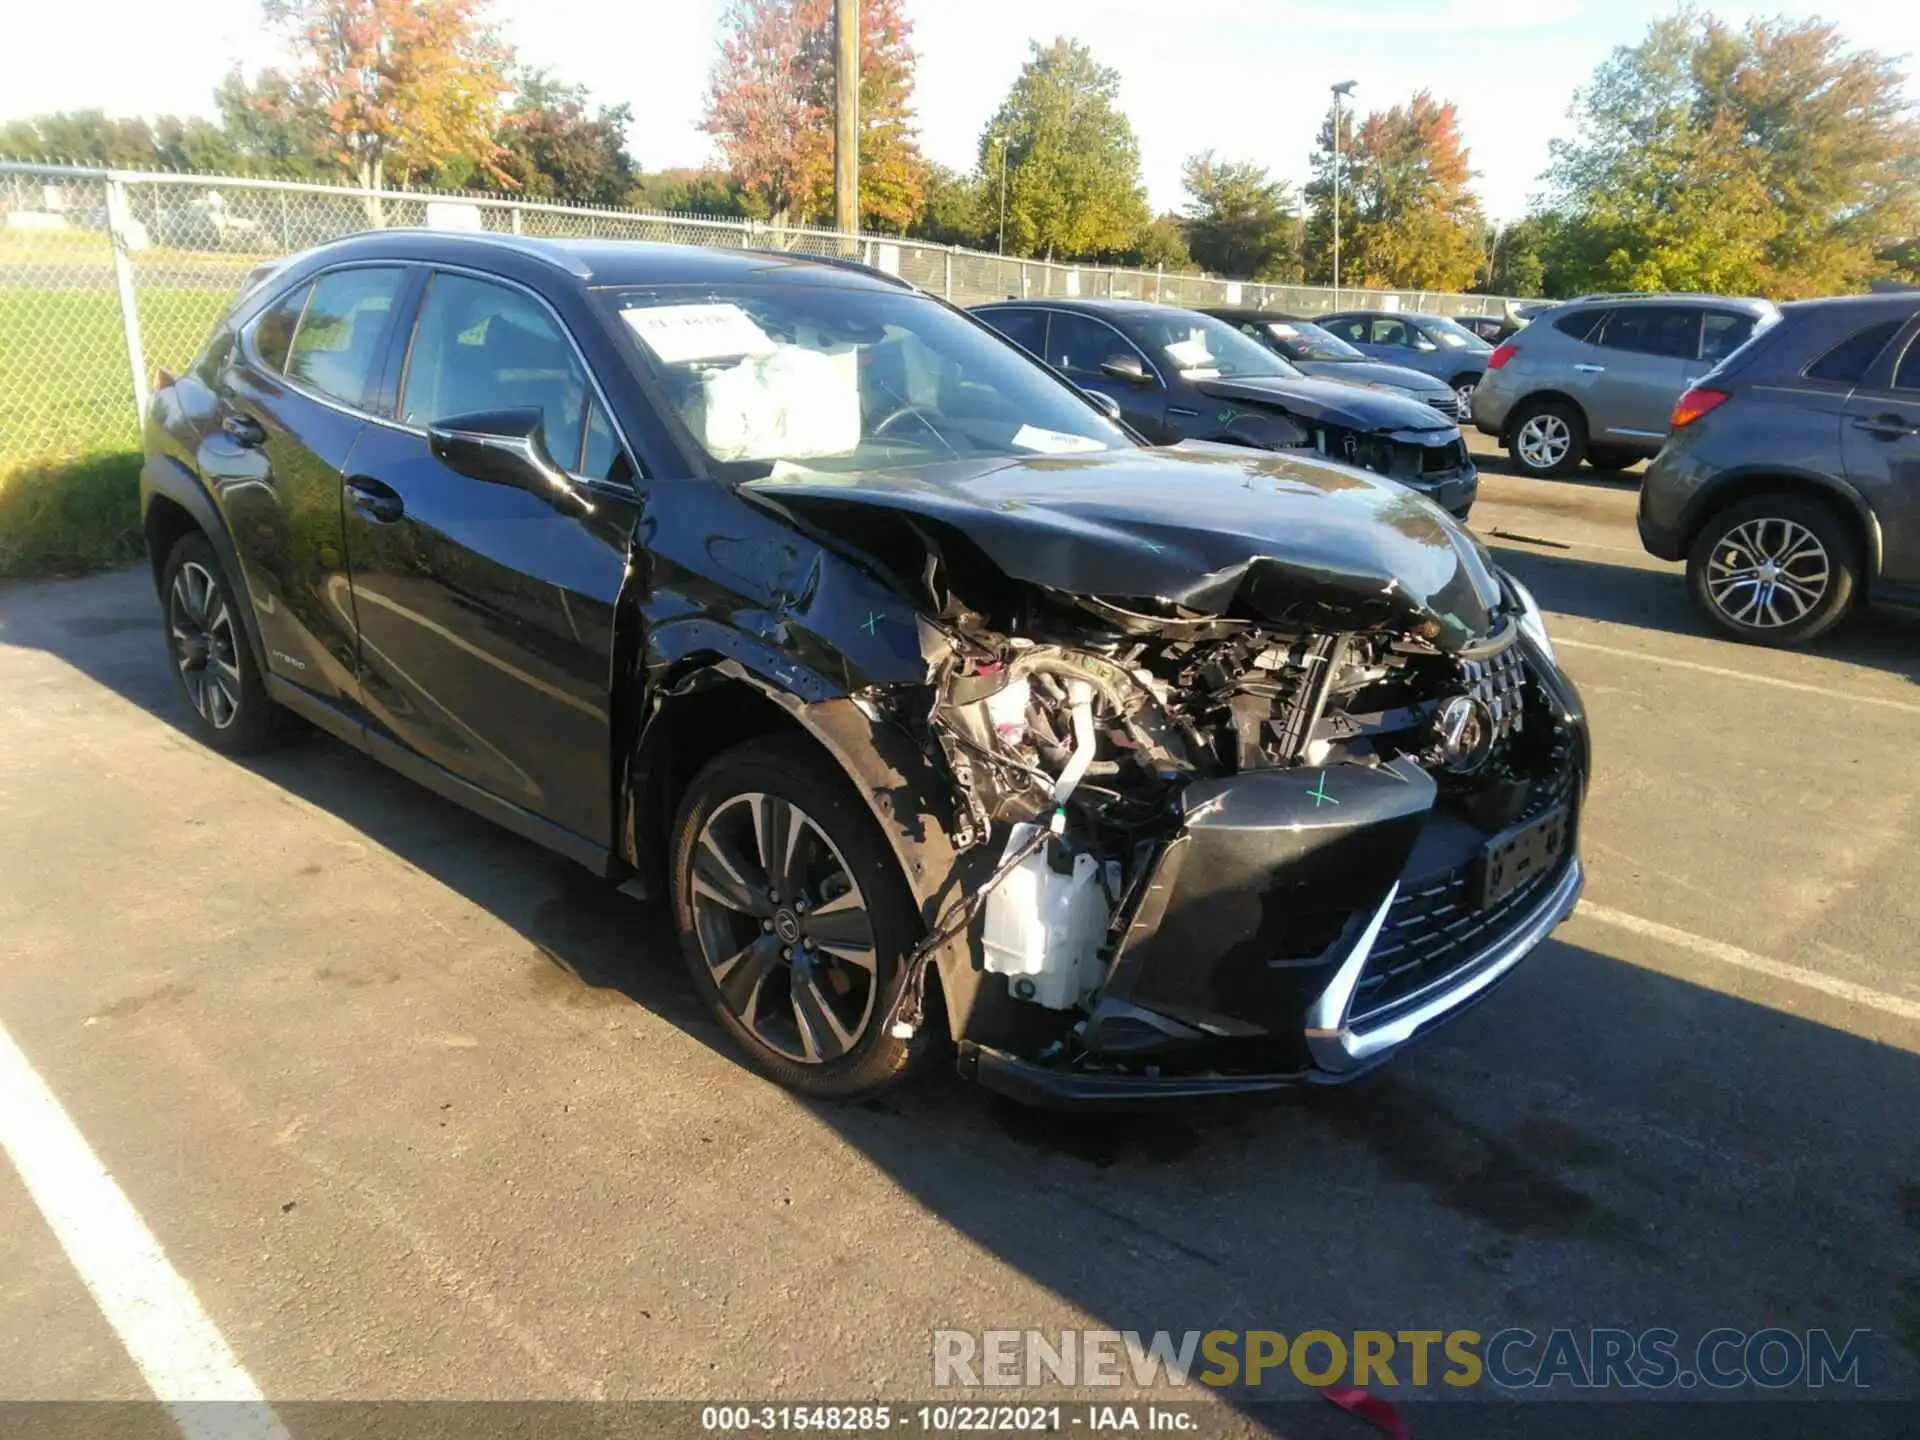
left=1549, top=12, right=1920, bottom=298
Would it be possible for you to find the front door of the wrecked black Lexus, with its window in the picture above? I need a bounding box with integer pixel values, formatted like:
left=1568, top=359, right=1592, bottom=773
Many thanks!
left=346, top=269, right=639, bottom=851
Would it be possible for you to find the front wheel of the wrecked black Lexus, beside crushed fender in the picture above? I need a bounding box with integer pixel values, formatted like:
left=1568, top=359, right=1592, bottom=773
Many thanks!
left=672, top=739, right=935, bottom=1100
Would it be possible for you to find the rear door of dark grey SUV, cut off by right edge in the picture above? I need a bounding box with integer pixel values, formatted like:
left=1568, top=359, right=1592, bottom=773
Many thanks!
left=1839, top=317, right=1920, bottom=586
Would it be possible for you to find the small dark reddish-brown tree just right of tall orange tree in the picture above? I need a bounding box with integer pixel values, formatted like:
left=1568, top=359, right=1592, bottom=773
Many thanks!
left=487, top=69, right=634, bottom=205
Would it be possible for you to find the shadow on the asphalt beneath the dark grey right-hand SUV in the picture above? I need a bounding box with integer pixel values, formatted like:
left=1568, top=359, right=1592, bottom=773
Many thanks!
left=1492, top=540, right=1920, bottom=684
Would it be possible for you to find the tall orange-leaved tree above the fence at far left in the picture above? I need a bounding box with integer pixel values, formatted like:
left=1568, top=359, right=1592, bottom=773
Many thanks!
left=265, top=0, right=509, bottom=188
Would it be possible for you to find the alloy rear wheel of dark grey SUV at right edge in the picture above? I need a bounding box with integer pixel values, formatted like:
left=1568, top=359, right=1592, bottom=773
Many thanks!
left=1686, top=495, right=1860, bottom=645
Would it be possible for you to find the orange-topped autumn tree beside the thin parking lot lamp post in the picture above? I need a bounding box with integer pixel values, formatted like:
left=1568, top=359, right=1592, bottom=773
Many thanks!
left=1308, top=90, right=1484, bottom=290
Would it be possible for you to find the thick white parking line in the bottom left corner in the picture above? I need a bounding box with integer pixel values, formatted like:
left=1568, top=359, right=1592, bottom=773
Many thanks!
left=0, top=1027, right=286, bottom=1440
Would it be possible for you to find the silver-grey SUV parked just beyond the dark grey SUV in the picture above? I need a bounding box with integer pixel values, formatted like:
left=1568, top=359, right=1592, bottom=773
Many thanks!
left=1473, top=294, right=1780, bottom=476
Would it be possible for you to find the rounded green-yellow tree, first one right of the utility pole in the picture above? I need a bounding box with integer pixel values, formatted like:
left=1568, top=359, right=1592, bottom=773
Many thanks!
left=979, top=36, right=1148, bottom=259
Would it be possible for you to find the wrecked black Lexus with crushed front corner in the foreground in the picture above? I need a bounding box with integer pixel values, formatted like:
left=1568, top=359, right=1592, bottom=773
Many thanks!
left=142, top=232, right=1588, bottom=1104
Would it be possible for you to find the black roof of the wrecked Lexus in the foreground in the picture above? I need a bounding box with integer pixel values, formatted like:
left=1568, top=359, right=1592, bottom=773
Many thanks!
left=286, top=228, right=912, bottom=290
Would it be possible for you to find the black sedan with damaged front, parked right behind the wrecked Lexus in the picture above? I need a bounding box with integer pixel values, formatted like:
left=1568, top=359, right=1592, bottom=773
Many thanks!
left=973, top=300, right=1480, bottom=518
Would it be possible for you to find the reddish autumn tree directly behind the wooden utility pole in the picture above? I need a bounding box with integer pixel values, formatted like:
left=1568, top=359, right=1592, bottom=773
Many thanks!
left=705, top=0, right=925, bottom=230
